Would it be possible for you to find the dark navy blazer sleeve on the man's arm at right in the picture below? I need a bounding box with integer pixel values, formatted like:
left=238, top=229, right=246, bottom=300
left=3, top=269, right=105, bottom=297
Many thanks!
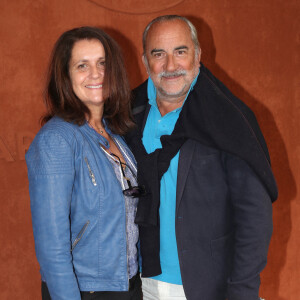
left=226, top=155, right=273, bottom=300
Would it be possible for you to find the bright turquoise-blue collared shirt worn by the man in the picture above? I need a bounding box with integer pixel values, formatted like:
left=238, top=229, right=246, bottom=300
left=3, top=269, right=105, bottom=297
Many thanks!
left=142, top=73, right=199, bottom=284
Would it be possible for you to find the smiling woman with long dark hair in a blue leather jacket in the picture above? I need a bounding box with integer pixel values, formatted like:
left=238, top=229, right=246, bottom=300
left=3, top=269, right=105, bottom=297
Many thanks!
left=26, top=27, right=141, bottom=300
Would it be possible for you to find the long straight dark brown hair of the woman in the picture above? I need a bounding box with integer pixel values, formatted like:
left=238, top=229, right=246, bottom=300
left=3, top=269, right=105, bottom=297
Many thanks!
left=42, top=27, right=133, bottom=134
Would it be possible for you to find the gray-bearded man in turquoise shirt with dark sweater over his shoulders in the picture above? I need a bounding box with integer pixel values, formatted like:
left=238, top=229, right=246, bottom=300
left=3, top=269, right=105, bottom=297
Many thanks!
left=127, top=16, right=277, bottom=300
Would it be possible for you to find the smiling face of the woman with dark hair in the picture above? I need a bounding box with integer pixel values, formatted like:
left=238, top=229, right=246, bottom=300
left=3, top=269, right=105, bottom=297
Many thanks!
left=69, top=39, right=105, bottom=110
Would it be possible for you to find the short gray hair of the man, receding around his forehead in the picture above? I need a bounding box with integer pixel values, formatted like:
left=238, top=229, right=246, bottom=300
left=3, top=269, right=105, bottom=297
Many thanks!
left=143, top=15, right=200, bottom=56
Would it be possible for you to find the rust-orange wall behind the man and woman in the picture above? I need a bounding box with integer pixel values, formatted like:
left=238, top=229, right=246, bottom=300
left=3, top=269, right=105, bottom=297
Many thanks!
left=0, top=0, right=300, bottom=300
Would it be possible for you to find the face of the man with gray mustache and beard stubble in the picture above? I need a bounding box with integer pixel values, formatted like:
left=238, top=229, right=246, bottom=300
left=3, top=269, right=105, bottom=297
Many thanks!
left=143, top=20, right=200, bottom=102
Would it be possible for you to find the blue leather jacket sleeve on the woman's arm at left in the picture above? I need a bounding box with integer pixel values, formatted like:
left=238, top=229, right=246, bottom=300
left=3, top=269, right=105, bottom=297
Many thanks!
left=26, top=128, right=81, bottom=300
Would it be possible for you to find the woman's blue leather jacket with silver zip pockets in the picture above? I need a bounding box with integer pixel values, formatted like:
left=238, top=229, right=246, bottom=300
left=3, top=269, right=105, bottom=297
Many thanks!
left=26, top=117, right=134, bottom=300
